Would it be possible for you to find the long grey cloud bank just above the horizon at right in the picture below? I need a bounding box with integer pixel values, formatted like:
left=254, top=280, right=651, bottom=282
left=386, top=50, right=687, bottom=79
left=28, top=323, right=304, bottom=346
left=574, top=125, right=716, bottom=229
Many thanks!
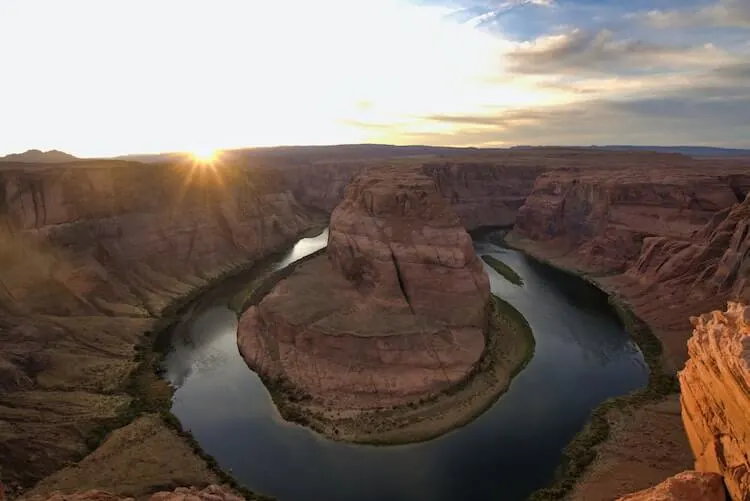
left=420, top=98, right=750, bottom=147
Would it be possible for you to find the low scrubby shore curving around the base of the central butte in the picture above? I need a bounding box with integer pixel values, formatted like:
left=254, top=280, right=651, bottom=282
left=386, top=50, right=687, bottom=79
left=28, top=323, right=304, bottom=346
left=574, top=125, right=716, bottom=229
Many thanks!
left=245, top=278, right=534, bottom=445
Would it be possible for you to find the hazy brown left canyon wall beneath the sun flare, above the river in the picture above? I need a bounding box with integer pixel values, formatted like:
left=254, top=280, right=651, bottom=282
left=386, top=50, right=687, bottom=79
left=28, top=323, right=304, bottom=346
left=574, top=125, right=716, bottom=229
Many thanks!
left=0, top=161, right=312, bottom=487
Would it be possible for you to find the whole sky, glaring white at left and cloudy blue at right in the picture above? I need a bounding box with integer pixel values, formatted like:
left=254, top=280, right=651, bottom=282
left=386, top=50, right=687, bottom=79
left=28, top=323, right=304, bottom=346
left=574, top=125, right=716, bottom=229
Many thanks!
left=0, top=0, right=750, bottom=156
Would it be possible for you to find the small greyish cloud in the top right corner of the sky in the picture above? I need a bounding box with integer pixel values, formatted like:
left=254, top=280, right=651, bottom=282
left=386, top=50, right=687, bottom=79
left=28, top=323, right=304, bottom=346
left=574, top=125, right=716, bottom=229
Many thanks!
left=644, top=0, right=750, bottom=28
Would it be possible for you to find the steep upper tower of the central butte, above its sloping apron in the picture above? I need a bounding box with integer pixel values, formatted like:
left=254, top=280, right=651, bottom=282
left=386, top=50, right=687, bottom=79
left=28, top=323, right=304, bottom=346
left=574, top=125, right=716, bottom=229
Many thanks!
left=328, top=169, right=489, bottom=328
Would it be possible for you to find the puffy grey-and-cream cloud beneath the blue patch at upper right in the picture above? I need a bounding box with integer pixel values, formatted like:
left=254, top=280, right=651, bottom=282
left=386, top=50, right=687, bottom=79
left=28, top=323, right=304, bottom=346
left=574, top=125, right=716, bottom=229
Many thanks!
left=506, top=29, right=728, bottom=75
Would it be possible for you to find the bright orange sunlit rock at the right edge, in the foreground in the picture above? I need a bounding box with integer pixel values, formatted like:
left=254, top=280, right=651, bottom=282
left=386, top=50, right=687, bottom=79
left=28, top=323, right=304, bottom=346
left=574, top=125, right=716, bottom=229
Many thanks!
left=680, top=303, right=750, bottom=500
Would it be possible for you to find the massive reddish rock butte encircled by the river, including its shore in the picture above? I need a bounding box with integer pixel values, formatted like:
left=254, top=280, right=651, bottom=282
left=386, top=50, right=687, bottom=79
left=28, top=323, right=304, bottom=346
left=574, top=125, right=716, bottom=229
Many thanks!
left=238, top=168, right=530, bottom=442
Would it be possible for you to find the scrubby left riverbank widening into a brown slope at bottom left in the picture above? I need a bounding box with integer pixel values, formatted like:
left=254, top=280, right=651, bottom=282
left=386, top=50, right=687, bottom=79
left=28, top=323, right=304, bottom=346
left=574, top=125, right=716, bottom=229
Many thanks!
left=23, top=225, right=326, bottom=500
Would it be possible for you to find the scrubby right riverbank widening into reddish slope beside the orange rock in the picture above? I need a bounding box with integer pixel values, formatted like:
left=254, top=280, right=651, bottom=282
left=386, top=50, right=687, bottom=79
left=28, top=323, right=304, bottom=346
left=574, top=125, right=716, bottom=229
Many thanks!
left=503, top=235, right=692, bottom=501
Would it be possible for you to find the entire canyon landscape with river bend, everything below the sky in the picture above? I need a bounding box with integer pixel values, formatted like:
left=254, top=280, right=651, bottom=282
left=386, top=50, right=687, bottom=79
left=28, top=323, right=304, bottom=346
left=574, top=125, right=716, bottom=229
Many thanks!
left=0, top=146, right=750, bottom=501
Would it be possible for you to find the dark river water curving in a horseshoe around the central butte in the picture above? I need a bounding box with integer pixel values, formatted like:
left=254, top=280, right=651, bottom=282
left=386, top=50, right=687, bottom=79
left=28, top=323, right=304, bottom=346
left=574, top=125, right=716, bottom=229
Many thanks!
left=164, top=234, right=648, bottom=501
